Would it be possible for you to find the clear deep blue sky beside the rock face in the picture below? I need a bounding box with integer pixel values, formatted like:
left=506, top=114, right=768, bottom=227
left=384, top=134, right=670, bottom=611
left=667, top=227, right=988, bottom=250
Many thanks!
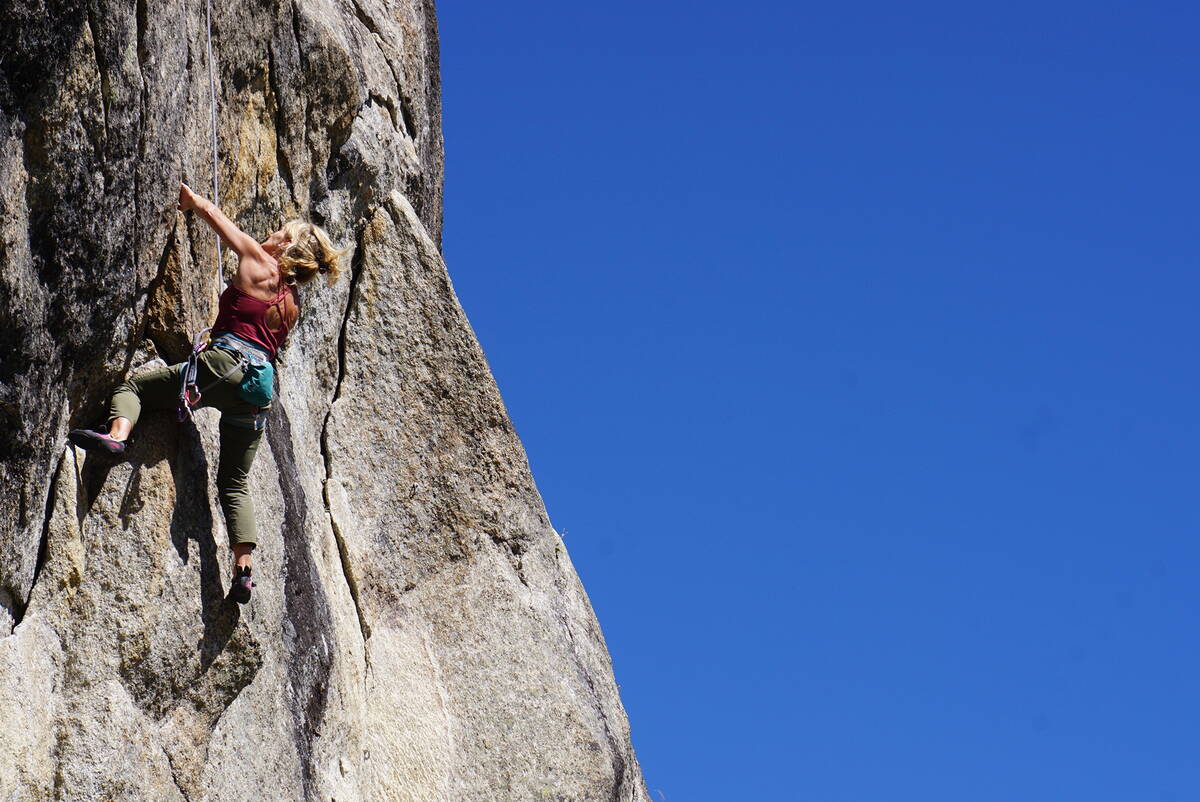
left=438, top=0, right=1200, bottom=802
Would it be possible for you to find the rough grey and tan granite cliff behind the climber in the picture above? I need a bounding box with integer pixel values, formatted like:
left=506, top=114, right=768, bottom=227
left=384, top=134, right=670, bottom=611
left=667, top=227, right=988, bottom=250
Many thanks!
left=0, top=0, right=647, bottom=800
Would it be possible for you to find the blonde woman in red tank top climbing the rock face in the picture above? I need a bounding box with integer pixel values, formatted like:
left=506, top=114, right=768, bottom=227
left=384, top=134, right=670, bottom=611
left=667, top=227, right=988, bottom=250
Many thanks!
left=67, top=184, right=343, bottom=604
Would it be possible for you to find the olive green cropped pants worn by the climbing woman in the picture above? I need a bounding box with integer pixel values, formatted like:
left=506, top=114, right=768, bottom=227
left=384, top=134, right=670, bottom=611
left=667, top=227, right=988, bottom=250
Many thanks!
left=108, top=348, right=270, bottom=547
